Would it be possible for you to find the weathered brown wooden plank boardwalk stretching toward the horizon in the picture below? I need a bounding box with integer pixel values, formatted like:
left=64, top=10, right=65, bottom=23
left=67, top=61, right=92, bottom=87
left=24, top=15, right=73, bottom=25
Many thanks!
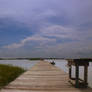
left=0, top=61, right=92, bottom=92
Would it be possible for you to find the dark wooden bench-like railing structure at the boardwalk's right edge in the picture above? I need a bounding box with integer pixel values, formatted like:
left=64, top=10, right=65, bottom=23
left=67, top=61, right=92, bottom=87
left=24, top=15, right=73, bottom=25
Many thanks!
left=67, top=59, right=92, bottom=88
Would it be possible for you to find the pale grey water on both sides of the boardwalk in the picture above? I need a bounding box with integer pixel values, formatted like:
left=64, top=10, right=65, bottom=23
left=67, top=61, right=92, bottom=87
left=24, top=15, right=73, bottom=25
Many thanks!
left=0, top=60, right=92, bottom=87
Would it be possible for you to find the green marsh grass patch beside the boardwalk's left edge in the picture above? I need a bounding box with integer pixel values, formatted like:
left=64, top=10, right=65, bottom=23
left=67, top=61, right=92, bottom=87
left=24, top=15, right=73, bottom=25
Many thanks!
left=0, top=64, right=25, bottom=89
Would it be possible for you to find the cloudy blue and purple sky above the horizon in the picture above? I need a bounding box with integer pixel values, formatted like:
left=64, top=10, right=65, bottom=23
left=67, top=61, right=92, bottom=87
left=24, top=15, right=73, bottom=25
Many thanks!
left=0, top=0, right=92, bottom=58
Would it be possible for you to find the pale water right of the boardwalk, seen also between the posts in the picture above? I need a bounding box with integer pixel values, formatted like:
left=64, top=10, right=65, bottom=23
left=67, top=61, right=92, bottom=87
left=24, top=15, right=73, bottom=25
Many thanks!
left=47, top=60, right=92, bottom=87
